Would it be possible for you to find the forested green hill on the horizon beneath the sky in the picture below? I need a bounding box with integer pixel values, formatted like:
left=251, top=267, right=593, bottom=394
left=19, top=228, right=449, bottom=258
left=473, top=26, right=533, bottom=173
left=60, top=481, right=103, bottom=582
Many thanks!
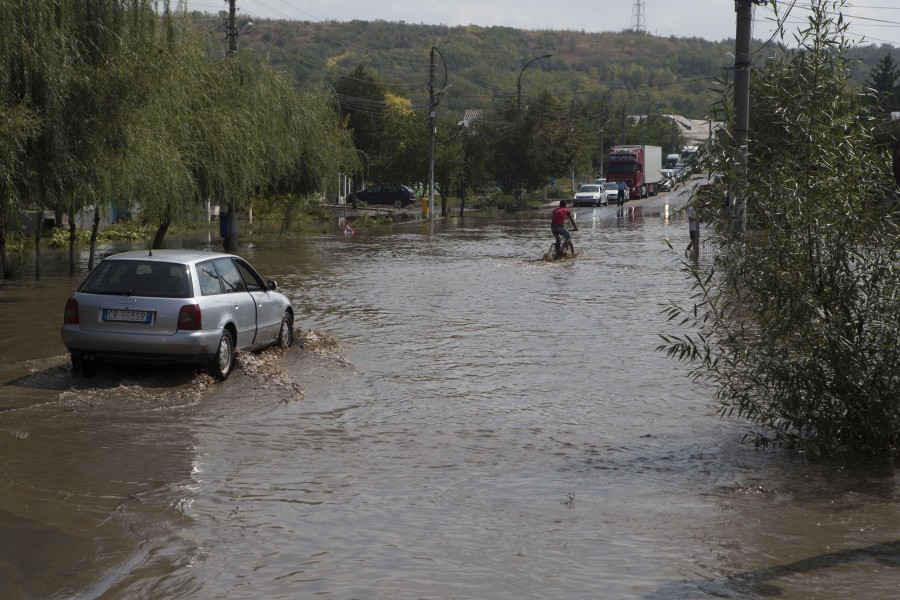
left=192, top=13, right=900, bottom=118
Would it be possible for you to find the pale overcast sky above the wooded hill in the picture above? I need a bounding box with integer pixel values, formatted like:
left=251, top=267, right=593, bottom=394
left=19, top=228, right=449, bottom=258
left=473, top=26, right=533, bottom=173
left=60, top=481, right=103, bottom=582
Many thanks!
left=187, top=0, right=900, bottom=47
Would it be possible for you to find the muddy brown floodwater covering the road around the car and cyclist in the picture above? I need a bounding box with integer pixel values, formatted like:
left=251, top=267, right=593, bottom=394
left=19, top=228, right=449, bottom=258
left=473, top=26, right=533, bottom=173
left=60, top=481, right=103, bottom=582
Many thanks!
left=0, top=195, right=900, bottom=600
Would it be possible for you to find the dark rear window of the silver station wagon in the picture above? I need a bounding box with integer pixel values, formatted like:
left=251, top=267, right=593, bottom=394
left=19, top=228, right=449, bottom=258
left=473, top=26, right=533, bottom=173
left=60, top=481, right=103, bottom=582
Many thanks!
left=78, top=260, right=192, bottom=298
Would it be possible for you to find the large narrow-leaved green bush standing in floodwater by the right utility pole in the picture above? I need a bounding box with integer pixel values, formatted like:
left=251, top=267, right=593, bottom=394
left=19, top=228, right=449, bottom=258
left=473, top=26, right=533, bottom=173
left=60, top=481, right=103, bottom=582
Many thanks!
left=660, top=0, right=900, bottom=456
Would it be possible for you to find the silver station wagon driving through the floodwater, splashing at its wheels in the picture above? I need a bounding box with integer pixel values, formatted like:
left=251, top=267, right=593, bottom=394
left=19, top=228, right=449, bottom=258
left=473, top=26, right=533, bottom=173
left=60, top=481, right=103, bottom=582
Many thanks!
left=61, top=250, right=294, bottom=380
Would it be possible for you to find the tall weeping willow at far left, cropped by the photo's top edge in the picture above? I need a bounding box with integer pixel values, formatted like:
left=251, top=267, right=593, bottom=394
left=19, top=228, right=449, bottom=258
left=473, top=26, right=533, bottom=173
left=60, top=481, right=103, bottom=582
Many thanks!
left=0, top=0, right=183, bottom=272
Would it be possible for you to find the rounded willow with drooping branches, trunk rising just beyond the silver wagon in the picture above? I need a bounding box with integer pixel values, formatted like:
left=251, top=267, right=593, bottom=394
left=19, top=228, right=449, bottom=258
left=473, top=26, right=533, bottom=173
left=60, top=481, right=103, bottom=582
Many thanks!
left=179, top=50, right=351, bottom=252
